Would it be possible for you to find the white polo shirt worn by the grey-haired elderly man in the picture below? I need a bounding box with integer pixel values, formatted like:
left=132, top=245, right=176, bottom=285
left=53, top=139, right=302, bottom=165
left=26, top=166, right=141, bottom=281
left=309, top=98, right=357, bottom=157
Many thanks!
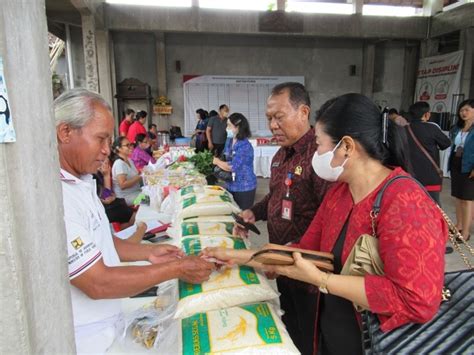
left=60, top=169, right=121, bottom=353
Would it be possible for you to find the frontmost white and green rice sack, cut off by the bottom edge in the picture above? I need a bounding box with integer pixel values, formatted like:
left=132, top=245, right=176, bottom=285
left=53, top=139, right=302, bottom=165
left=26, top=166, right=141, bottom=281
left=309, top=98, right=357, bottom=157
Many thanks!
left=155, top=303, right=299, bottom=355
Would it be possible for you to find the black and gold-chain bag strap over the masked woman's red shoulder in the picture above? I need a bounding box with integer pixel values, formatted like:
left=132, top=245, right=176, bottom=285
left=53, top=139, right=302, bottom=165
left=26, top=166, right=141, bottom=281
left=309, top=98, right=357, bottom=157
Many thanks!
left=370, top=175, right=474, bottom=269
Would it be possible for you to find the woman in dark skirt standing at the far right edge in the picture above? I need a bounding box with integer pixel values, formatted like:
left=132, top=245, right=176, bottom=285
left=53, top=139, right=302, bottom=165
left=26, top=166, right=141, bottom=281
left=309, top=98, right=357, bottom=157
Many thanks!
left=449, top=99, right=474, bottom=240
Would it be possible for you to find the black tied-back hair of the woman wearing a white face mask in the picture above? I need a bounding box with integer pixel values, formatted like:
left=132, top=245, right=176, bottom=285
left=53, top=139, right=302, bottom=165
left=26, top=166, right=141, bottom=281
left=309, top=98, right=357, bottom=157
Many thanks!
left=316, top=94, right=412, bottom=172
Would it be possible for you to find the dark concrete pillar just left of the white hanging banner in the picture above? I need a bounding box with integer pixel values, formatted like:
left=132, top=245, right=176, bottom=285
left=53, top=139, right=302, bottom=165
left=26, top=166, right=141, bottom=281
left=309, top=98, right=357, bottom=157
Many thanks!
left=400, top=44, right=418, bottom=111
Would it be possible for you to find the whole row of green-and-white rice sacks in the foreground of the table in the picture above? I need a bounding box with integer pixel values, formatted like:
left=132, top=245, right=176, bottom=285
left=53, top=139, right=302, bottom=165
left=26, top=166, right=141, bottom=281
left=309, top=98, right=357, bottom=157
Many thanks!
left=155, top=186, right=298, bottom=354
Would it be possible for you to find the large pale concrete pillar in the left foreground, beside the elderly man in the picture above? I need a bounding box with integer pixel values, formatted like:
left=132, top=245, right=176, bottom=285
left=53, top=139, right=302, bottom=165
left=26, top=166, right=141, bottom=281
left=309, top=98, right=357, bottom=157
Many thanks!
left=0, top=0, right=75, bottom=354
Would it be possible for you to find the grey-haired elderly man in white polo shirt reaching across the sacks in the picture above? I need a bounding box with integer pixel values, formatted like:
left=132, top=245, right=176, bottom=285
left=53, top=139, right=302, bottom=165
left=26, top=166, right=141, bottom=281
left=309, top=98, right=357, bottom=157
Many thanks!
left=54, top=89, right=213, bottom=354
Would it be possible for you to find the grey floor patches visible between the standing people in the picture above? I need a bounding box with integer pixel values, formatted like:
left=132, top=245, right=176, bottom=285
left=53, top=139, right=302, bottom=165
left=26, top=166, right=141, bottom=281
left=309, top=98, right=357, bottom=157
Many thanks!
left=246, top=178, right=474, bottom=271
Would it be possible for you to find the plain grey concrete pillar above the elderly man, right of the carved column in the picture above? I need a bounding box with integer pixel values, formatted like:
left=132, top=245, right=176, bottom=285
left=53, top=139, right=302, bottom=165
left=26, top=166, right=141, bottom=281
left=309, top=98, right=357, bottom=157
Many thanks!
left=95, top=30, right=114, bottom=106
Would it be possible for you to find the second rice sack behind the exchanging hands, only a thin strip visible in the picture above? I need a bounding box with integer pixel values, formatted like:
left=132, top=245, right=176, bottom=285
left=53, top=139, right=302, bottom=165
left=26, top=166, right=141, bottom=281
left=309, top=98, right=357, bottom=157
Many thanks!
left=167, top=221, right=234, bottom=238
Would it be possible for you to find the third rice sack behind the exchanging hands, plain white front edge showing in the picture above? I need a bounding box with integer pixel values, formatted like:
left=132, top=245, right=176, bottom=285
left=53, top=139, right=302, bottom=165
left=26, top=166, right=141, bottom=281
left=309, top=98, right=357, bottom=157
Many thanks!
left=175, top=194, right=241, bottom=220
